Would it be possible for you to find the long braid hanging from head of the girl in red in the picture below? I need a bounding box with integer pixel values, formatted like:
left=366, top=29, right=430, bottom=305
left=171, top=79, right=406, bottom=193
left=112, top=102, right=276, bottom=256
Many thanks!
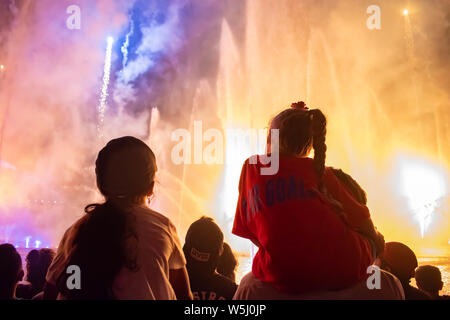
left=309, top=109, right=327, bottom=191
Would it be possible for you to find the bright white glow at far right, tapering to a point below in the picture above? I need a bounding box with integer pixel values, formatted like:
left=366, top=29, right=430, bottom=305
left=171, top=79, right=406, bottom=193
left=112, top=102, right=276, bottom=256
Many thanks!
left=399, top=159, right=447, bottom=238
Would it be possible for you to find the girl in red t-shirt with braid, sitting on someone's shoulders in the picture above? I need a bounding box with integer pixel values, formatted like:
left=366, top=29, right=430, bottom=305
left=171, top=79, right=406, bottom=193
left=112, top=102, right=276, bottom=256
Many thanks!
left=233, top=102, right=382, bottom=293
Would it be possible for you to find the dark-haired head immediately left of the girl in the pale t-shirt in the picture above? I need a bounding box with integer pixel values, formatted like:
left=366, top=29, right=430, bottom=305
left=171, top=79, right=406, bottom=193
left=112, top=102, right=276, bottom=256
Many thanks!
left=25, top=248, right=55, bottom=293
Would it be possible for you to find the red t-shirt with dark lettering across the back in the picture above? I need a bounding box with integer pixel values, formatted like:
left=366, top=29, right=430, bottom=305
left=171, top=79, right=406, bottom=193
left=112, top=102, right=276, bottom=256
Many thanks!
left=233, top=157, right=372, bottom=293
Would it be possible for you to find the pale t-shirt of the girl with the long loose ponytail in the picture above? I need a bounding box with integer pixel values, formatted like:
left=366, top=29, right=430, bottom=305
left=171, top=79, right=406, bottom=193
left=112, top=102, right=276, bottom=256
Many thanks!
left=47, top=206, right=186, bottom=300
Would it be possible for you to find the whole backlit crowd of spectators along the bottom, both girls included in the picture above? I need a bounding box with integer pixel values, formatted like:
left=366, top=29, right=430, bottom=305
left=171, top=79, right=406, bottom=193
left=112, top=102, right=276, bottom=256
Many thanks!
left=0, top=102, right=448, bottom=300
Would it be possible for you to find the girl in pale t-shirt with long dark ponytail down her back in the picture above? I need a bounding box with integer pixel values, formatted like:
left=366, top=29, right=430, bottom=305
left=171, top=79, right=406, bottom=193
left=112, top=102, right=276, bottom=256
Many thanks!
left=44, top=137, right=191, bottom=300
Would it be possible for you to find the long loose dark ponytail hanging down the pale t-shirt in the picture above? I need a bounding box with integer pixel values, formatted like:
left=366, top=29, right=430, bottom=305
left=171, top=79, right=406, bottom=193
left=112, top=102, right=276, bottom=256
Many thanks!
left=58, top=200, right=137, bottom=300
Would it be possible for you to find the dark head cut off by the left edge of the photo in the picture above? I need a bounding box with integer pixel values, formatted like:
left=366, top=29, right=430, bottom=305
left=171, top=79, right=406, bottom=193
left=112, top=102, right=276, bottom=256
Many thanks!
left=0, top=243, right=22, bottom=291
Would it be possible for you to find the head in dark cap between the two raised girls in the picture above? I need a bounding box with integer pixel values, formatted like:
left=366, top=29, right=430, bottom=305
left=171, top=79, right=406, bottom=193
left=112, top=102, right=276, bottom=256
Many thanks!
left=183, top=217, right=223, bottom=272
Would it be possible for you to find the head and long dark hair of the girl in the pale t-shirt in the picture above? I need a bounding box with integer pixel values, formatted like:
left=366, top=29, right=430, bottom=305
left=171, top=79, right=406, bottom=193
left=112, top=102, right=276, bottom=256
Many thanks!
left=58, top=137, right=157, bottom=300
